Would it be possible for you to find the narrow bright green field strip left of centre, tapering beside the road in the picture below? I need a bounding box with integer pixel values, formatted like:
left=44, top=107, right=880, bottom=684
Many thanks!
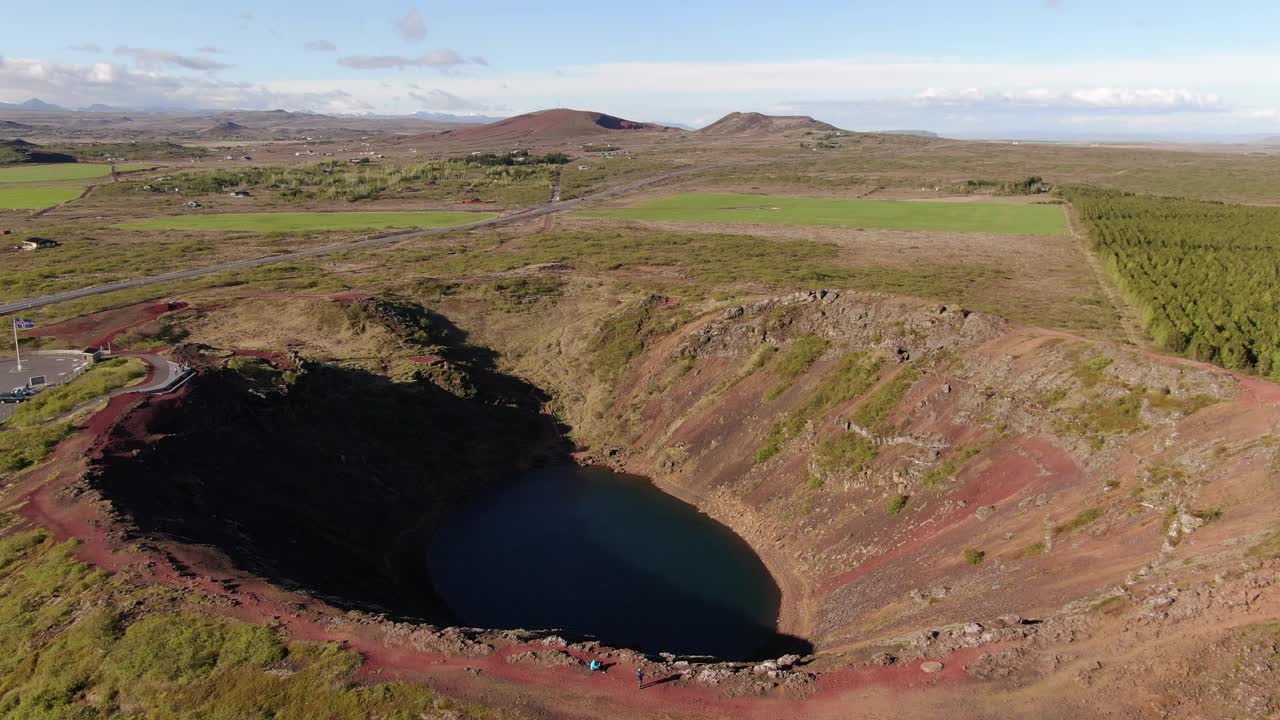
left=115, top=210, right=497, bottom=232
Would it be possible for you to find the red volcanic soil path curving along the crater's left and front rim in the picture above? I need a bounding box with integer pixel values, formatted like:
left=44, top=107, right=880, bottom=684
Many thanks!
left=2, top=386, right=992, bottom=720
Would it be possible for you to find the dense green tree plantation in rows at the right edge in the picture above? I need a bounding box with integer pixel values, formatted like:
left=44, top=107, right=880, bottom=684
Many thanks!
left=1068, top=188, right=1280, bottom=379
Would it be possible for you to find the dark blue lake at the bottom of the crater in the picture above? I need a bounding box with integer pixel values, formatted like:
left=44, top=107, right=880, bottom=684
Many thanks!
left=430, top=466, right=780, bottom=659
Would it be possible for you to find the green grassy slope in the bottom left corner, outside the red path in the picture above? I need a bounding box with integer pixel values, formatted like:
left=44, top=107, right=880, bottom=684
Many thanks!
left=0, top=530, right=513, bottom=720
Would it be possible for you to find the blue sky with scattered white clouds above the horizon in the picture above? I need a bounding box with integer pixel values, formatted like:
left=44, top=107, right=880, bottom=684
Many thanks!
left=0, top=0, right=1280, bottom=137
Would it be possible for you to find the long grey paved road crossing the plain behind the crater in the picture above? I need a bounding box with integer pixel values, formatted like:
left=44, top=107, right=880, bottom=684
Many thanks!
left=0, top=142, right=961, bottom=316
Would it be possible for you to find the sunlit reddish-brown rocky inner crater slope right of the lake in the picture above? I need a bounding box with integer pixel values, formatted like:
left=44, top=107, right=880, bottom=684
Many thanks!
left=586, top=293, right=1280, bottom=652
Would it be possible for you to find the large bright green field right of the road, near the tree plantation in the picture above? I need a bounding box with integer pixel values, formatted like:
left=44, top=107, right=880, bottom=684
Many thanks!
left=588, top=192, right=1068, bottom=234
